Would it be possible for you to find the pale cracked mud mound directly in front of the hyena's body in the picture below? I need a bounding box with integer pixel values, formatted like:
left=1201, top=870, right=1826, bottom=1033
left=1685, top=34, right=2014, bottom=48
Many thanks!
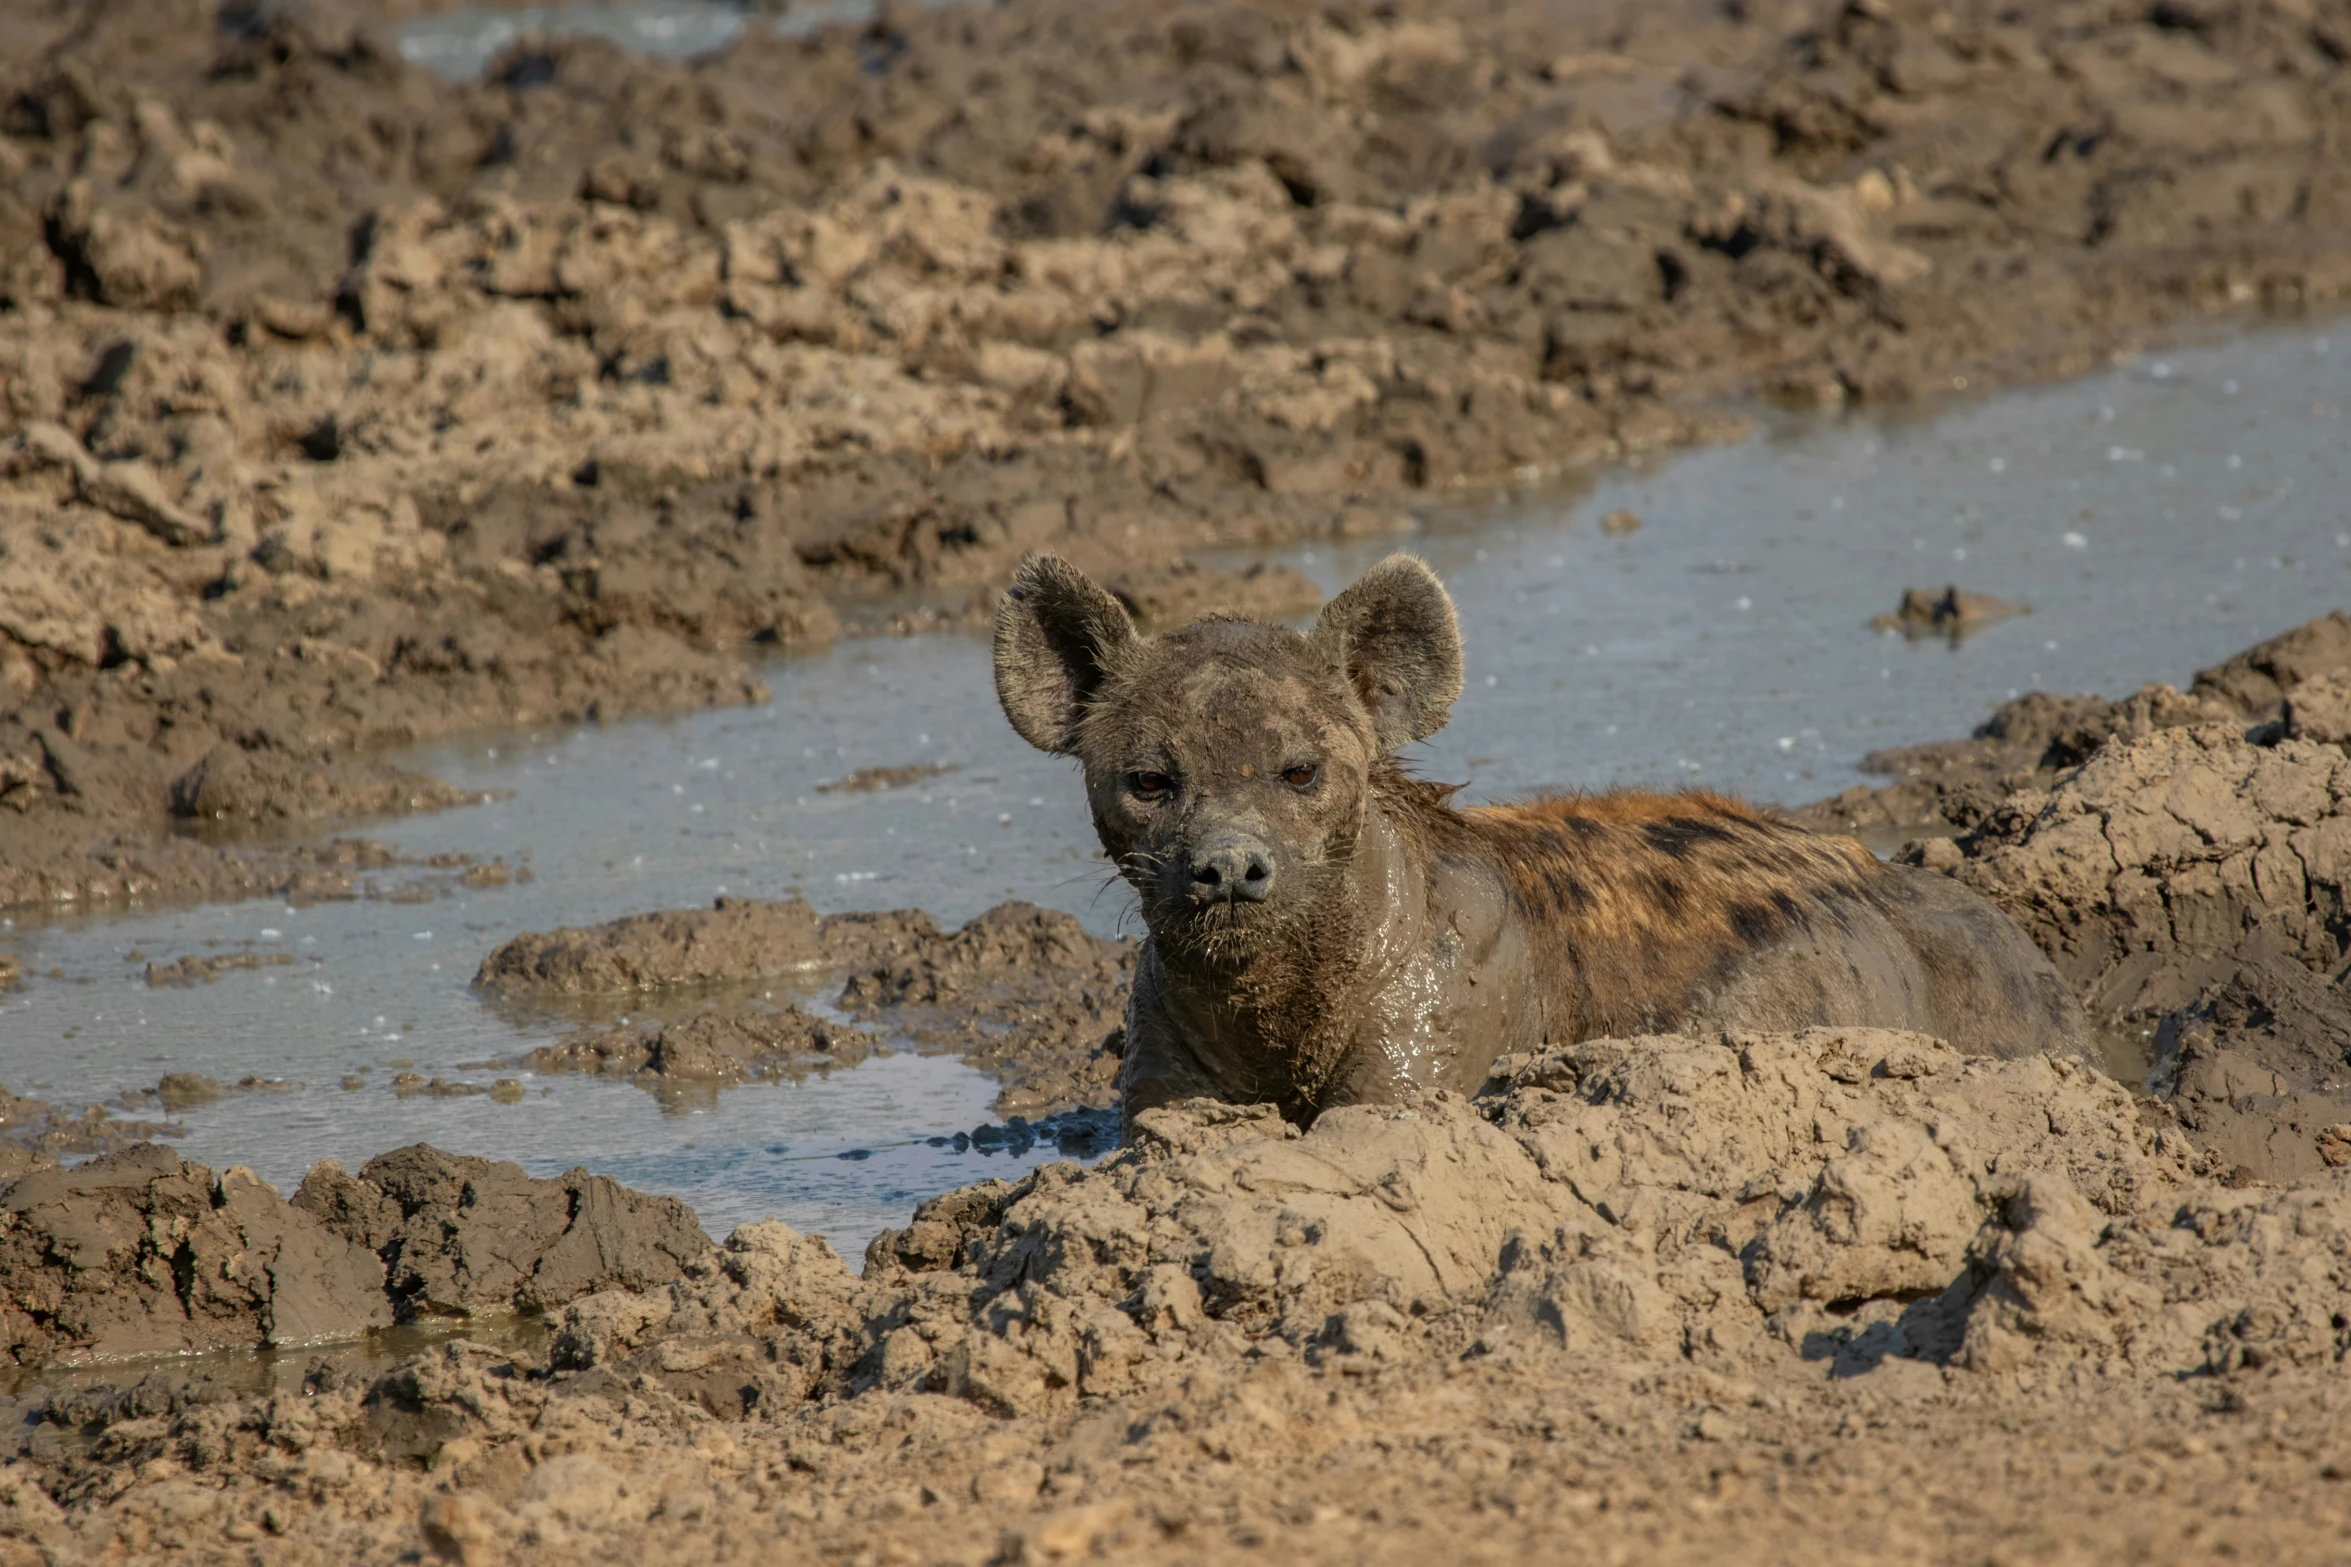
left=514, top=1029, right=2238, bottom=1414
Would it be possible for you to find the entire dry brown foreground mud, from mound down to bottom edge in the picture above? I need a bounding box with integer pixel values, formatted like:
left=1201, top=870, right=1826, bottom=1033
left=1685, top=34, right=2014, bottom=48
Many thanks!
left=7, top=1031, right=2351, bottom=1562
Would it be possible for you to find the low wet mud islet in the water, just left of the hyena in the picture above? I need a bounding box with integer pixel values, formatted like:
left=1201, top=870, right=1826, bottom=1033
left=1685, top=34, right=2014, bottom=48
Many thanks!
left=475, top=897, right=1136, bottom=1118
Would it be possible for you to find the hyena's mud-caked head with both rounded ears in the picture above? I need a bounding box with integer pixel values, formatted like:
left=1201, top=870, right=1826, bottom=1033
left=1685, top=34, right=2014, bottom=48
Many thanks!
left=997, top=554, right=1462, bottom=963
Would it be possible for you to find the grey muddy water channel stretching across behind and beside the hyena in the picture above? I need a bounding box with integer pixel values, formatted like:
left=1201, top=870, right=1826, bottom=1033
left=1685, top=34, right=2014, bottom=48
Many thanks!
left=0, top=329, right=2351, bottom=1257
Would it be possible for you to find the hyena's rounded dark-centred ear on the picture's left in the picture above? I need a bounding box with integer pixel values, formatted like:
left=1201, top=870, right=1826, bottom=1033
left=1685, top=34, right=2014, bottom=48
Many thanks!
left=997, top=554, right=1143, bottom=756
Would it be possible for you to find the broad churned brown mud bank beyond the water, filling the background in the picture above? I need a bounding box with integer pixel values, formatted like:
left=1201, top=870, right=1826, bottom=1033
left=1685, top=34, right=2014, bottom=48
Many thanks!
left=0, top=0, right=2351, bottom=902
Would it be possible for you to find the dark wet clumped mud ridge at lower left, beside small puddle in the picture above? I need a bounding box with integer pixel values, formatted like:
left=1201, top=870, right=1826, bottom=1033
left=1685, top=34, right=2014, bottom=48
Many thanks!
left=0, top=1141, right=708, bottom=1367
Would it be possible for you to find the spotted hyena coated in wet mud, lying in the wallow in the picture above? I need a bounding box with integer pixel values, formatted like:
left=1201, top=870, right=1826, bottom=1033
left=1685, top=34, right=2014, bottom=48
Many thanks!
left=994, top=554, right=2088, bottom=1121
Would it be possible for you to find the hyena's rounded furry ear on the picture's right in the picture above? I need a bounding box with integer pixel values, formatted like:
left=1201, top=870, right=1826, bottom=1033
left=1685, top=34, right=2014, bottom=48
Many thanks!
left=1314, top=554, right=1462, bottom=752
